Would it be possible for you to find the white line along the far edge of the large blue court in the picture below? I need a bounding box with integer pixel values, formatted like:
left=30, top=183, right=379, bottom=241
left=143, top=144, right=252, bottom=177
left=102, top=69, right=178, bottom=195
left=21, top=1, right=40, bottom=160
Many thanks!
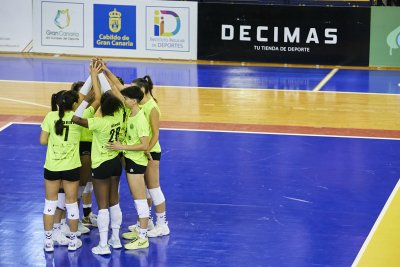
left=3, top=121, right=400, bottom=141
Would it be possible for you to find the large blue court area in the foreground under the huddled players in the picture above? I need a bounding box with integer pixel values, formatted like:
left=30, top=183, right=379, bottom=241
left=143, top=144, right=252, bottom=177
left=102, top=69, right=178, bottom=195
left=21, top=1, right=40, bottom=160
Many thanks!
left=0, top=124, right=400, bottom=267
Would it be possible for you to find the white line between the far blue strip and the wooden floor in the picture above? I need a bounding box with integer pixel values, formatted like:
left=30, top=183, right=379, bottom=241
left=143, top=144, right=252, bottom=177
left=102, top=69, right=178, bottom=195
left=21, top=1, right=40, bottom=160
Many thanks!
left=0, top=79, right=399, bottom=96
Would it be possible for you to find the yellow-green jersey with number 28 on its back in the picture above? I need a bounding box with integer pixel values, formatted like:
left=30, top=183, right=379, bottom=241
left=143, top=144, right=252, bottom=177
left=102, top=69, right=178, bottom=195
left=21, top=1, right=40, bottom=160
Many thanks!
left=88, top=113, right=123, bottom=168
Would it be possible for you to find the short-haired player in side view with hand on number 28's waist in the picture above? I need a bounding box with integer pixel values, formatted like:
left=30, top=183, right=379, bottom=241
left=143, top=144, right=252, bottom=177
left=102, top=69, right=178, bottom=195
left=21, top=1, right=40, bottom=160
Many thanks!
left=108, top=86, right=149, bottom=249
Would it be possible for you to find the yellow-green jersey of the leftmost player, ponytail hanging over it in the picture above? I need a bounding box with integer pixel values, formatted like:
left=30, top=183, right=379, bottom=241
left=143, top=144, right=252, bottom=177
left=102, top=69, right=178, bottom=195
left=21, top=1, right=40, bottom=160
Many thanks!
left=41, top=111, right=82, bottom=171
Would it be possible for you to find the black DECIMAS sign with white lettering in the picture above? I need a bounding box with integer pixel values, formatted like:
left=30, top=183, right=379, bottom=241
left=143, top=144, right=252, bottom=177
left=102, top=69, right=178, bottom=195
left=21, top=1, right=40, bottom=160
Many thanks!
left=197, top=3, right=370, bottom=66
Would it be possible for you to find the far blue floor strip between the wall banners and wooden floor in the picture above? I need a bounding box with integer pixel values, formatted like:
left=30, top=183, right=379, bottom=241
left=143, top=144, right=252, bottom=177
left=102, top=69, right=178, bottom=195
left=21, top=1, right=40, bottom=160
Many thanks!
left=0, top=57, right=400, bottom=94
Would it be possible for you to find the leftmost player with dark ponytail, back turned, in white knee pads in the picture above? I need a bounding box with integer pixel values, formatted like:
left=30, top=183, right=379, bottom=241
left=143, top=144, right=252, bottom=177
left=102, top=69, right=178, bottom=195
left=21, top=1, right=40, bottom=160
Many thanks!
left=40, top=91, right=82, bottom=252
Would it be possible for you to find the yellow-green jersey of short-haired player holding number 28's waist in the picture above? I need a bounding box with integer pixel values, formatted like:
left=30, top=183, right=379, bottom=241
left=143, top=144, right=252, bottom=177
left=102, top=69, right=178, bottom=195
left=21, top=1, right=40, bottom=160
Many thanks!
left=124, top=110, right=149, bottom=166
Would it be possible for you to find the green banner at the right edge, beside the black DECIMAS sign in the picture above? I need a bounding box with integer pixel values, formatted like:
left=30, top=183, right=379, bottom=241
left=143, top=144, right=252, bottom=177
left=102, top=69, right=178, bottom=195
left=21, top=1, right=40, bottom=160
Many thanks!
left=369, top=7, right=400, bottom=67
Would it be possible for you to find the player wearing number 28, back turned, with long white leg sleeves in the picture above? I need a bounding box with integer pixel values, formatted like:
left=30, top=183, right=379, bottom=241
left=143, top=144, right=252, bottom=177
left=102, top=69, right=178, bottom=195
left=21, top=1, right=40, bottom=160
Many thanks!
left=72, top=66, right=123, bottom=255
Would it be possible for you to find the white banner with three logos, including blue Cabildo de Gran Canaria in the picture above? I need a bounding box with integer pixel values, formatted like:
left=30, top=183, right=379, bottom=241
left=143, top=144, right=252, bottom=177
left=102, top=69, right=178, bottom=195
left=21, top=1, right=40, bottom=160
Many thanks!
left=33, top=0, right=197, bottom=60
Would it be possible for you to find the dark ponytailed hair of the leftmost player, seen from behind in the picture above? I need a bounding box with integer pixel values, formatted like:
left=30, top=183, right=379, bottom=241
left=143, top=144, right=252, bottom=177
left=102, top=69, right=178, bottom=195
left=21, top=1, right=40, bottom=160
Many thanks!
left=51, top=90, right=79, bottom=135
